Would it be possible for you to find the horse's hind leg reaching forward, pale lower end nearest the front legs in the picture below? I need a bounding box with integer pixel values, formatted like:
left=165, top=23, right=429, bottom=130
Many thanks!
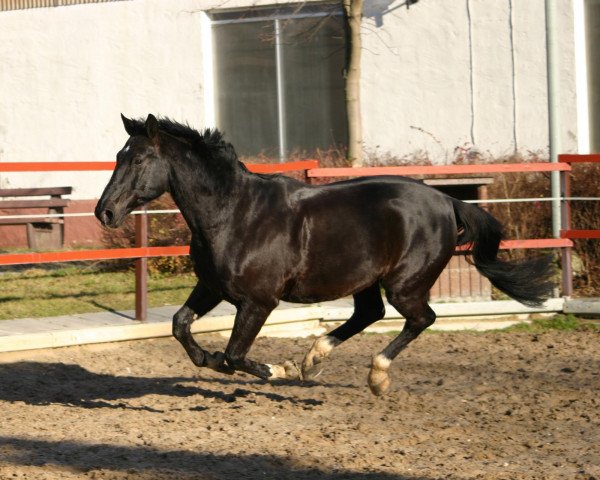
left=302, top=282, right=385, bottom=380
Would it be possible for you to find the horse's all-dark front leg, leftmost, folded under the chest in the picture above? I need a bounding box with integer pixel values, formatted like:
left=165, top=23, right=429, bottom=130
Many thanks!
left=173, top=283, right=233, bottom=373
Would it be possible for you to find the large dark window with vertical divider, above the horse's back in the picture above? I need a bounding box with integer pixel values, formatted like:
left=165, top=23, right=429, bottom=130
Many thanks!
left=211, top=4, right=347, bottom=161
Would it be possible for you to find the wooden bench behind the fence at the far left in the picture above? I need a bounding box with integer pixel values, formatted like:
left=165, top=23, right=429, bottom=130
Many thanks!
left=0, top=187, right=73, bottom=250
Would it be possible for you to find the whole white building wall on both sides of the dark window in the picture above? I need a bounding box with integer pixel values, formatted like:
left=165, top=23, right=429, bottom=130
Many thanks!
left=0, top=0, right=577, bottom=198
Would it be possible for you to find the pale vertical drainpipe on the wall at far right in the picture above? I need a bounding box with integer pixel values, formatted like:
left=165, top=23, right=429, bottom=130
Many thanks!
left=545, top=0, right=561, bottom=238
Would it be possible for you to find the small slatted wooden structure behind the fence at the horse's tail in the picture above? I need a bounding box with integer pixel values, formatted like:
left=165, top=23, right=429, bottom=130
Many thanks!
left=424, top=177, right=494, bottom=301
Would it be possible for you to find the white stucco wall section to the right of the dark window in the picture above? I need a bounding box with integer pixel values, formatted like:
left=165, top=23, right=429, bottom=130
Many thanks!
left=363, top=0, right=576, bottom=162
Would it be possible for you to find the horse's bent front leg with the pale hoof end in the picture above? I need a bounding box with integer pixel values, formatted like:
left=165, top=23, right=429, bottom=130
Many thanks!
left=225, top=301, right=300, bottom=380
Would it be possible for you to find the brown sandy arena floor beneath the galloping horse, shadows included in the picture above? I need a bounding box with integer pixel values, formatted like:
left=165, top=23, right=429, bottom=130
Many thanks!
left=0, top=333, right=600, bottom=480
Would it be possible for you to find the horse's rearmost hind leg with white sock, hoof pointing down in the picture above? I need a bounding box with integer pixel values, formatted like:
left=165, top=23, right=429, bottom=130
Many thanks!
left=368, top=294, right=435, bottom=395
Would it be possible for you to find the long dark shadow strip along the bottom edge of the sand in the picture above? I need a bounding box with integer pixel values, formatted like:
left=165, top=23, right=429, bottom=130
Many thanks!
left=0, top=436, right=432, bottom=480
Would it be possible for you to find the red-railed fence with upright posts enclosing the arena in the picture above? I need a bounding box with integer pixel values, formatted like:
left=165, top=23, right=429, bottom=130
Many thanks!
left=0, top=155, right=600, bottom=320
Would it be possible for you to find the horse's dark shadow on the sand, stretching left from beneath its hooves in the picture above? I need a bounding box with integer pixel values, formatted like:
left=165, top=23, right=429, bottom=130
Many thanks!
left=0, top=361, right=322, bottom=412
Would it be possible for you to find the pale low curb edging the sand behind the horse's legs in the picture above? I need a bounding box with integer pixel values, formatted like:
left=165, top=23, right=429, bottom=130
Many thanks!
left=0, top=299, right=564, bottom=352
